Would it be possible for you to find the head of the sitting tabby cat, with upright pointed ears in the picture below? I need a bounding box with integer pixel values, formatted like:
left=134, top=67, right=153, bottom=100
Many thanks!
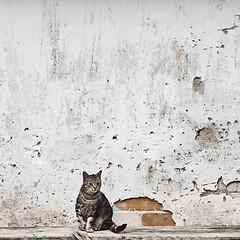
left=82, top=170, right=102, bottom=195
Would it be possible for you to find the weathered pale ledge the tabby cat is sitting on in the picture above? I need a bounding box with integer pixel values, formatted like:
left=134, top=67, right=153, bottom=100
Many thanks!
left=0, top=226, right=240, bottom=240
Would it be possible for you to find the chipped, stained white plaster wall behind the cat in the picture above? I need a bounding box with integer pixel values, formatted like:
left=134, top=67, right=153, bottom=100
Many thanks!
left=0, top=0, right=240, bottom=227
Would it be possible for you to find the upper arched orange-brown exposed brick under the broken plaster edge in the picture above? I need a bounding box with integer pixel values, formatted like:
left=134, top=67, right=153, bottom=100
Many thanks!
left=114, top=197, right=163, bottom=211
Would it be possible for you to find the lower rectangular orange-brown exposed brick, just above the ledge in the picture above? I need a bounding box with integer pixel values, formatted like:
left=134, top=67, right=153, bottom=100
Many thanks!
left=142, top=212, right=176, bottom=226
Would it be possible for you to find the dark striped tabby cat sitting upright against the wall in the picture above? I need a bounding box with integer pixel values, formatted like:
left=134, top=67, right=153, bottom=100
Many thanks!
left=75, top=170, right=127, bottom=233
